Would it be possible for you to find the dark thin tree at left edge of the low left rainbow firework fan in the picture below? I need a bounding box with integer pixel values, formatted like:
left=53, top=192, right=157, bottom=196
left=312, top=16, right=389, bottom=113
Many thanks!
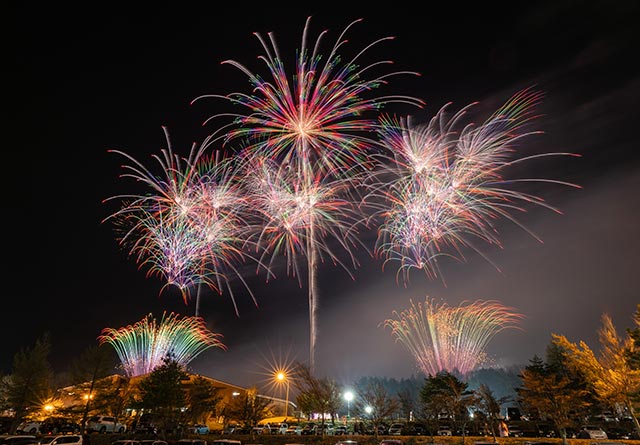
left=70, top=345, right=120, bottom=431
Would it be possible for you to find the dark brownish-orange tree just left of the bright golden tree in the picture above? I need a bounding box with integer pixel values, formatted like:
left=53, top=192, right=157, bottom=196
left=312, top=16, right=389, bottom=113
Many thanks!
left=516, top=356, right=589, bottom=444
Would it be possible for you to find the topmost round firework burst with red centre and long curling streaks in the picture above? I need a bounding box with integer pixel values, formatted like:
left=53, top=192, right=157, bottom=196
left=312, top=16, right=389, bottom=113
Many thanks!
left=193, top=17, right=423, bottom=176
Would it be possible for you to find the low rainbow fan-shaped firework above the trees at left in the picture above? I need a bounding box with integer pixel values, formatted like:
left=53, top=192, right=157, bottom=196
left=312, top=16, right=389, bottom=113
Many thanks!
left=98, top=313, right=226, bottom=377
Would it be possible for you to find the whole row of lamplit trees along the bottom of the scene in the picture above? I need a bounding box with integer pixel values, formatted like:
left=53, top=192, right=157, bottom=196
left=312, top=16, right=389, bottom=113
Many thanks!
left=0, top=304, right=640, bottom=443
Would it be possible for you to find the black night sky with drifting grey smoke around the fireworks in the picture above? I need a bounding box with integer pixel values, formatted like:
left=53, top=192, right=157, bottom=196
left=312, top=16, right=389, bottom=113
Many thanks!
left=6, top=1, right=640, bottom=385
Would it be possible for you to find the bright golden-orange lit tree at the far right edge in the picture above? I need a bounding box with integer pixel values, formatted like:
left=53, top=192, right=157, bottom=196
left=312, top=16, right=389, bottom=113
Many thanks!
left=552, top=314, right=640, bottom=435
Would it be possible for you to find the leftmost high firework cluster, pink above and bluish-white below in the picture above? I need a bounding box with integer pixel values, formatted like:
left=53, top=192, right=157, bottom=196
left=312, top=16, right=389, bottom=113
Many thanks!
left=105, top=129, right=262, bottom=315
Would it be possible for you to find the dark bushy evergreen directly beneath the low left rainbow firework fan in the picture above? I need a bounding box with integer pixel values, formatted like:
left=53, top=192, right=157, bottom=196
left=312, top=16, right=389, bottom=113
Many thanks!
left=138, top=356, right=189, bottom=435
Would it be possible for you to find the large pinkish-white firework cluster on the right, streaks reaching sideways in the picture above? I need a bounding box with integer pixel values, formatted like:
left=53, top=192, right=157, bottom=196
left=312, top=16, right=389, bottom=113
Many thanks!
left=365, top=89, right=578, bottom=283
